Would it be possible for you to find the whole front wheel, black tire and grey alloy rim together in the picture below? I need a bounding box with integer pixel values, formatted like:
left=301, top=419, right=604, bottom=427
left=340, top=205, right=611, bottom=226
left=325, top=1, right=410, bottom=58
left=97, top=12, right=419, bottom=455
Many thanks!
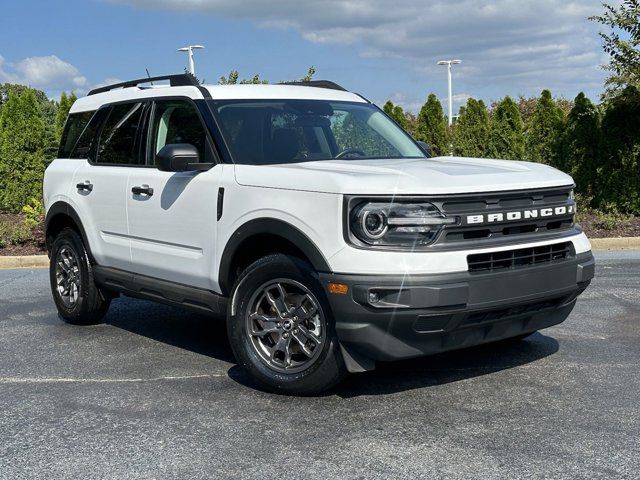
left=227, top=254, right=346, bottom=395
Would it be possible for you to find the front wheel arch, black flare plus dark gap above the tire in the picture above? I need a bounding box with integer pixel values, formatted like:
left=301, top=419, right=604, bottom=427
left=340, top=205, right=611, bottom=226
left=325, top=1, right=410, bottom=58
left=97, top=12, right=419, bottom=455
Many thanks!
left=218, top=218, right=331, bottom=295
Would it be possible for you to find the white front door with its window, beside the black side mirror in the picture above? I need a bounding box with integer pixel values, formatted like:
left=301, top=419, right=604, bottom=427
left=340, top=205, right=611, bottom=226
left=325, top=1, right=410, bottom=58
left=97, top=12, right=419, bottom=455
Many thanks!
left=126, top=99, right=223, bottom=289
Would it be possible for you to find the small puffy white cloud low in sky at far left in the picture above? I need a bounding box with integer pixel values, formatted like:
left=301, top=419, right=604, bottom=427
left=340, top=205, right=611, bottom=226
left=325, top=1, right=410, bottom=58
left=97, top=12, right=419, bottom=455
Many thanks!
left=0, top=55, right=88, bottom=92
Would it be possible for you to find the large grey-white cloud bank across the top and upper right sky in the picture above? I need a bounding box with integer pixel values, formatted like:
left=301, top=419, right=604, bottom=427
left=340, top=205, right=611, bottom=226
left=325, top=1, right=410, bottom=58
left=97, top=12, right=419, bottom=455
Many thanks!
left=111, top=0, right=606, bottom=98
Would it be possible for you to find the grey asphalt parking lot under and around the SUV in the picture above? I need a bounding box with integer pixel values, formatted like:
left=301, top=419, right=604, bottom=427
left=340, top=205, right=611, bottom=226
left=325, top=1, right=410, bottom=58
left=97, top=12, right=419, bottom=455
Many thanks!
left=0, top=252, right=640, bottom=479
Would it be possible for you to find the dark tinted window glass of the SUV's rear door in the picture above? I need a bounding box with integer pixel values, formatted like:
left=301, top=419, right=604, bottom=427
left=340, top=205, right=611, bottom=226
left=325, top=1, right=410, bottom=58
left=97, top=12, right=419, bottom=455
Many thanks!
left=96, top=103, right=144, bottom=165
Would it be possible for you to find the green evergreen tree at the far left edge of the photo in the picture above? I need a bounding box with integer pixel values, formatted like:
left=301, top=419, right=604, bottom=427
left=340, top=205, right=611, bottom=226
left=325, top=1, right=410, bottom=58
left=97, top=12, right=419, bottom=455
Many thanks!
left=0, top=90, right=46, bottom=213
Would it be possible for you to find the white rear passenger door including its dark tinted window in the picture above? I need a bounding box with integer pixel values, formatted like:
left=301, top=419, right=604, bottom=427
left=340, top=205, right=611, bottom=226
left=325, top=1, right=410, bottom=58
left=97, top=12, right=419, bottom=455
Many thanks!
left=72, top=102, right=147, bottom=270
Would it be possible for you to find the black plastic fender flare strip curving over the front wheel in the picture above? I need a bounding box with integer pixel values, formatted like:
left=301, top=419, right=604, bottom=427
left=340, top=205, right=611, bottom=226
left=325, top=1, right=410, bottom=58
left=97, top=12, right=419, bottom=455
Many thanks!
left=218, top=218, right=331, bottom=294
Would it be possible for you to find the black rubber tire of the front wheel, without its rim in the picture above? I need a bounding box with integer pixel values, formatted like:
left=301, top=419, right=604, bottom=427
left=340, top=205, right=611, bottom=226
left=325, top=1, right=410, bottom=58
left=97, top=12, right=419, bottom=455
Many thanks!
left=227, top=254, right=346, bottom=395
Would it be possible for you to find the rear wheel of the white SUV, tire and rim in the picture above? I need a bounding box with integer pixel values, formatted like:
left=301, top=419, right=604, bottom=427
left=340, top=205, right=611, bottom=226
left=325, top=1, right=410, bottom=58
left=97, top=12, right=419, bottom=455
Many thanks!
left=49, top=228, right=111, bottom=325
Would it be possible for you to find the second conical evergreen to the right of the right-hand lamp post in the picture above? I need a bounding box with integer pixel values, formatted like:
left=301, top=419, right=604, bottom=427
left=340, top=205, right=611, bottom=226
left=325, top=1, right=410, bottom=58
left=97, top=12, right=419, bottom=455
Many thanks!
left=489, top=96, right=524, bottom=160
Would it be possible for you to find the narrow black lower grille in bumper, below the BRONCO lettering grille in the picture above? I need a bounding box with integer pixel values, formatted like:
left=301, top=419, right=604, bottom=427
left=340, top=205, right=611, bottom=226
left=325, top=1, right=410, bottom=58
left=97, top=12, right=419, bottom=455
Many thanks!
left=467, top=242, right=573, bottom=272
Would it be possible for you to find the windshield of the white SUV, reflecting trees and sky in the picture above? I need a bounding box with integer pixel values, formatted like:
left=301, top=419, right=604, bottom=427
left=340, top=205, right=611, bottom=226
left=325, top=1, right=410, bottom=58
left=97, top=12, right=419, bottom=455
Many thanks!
left=211, top=100, right=425, bottom=165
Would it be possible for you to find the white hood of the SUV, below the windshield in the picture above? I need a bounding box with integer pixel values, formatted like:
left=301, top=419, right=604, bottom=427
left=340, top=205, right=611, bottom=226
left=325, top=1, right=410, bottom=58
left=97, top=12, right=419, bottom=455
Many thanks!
left=235, top=157, right=573, bottom=195
